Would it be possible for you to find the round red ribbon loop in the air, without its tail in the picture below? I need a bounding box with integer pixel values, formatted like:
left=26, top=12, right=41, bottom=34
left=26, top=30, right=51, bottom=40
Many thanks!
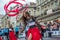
left=4, top=1, right=23, bottom=16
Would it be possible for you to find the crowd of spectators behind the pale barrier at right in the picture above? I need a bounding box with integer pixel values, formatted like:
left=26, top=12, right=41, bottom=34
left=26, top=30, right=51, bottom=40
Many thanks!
left=39, top=20, right=60, bottom=37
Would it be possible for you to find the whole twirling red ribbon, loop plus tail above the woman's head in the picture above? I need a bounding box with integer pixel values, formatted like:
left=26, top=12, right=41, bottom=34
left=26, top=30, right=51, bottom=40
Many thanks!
left=4, top=0, right=27, bottom=16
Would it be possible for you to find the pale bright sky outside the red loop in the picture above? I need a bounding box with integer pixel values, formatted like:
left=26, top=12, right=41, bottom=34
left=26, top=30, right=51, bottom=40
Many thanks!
left=0, top=0, right=36, bottom=15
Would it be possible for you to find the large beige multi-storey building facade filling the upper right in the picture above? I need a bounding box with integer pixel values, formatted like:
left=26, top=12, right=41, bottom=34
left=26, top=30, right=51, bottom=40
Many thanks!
left=36, top=0, right=60, bottom=21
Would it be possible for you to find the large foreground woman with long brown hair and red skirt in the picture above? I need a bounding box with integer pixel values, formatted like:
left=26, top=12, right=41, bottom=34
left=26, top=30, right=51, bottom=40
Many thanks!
left=23, top=12, right=42, bottom=40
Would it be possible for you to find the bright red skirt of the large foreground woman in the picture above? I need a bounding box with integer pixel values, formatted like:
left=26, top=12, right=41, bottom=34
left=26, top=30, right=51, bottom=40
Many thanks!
left=27, top=27, right=42, bottom=40
